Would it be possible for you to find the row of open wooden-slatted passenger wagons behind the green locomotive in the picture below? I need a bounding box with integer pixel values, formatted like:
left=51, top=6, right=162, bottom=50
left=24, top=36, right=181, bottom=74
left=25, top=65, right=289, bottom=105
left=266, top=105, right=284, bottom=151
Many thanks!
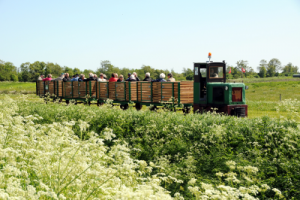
left=36, top=80, right=194, bottom=107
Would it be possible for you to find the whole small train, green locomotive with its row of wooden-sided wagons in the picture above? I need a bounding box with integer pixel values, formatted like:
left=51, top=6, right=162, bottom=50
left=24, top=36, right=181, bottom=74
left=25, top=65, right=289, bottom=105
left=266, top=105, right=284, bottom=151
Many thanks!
left=36, top=55, right=248, bottom=117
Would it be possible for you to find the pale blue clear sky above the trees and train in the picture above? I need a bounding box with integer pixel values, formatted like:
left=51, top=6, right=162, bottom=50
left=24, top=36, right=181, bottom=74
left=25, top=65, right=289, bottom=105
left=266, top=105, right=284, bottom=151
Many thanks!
left=0, top=0, right=300, bottom=72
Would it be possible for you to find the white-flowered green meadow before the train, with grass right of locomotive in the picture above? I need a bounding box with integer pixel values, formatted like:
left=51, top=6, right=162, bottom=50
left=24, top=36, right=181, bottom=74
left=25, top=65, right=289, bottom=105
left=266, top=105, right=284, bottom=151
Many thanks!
left=0, top=81, right=300, bottom=199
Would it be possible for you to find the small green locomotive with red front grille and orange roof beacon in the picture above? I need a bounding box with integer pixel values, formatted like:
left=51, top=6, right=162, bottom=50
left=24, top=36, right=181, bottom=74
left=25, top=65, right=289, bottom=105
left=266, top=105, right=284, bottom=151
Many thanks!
left=193, top=55, right=248, bottom=117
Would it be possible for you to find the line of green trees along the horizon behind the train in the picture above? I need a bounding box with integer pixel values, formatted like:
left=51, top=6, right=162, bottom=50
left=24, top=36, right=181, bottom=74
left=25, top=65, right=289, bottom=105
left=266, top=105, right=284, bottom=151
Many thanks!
left=0, top=58, right=299, bottom=82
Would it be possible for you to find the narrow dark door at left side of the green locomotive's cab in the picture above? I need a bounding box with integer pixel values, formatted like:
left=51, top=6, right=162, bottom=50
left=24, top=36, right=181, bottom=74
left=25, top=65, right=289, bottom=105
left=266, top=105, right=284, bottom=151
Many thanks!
left=194, top=63, right=207, bottom=104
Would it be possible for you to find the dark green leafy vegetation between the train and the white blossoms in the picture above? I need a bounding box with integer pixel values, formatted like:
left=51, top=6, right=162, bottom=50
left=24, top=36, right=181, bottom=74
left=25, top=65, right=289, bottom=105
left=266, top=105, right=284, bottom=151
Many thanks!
left=14, top=97, right=300, bottom=199
